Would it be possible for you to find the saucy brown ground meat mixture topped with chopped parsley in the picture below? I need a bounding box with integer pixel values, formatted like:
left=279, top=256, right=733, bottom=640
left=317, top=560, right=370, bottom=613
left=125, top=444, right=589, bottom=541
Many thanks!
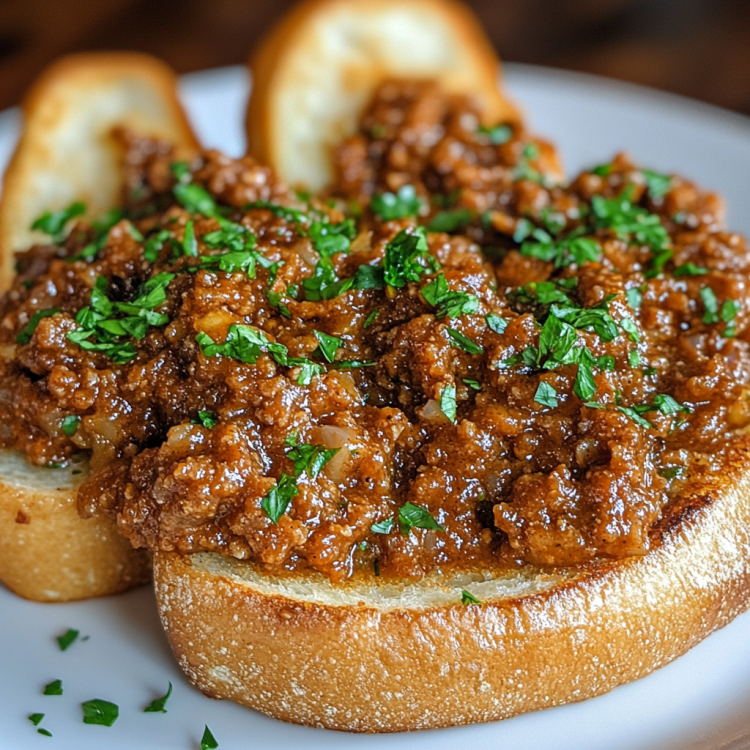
left=0, top=82, right=750, bottom=581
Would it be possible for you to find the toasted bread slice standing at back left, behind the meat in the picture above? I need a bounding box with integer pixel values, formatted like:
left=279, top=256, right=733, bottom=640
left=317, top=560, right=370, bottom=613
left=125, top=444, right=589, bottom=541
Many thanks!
left=0, top=52, right=198, bottom=290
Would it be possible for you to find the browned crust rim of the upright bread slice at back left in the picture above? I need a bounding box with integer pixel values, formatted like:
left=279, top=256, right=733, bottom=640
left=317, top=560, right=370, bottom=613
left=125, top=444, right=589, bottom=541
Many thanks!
left=0, top=52, right=199, bottom=291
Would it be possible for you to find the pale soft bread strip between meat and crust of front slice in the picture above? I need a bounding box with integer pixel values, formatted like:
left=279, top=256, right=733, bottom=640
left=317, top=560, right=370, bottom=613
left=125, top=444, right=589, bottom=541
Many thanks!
left=190, top=552, right=575, bottom=611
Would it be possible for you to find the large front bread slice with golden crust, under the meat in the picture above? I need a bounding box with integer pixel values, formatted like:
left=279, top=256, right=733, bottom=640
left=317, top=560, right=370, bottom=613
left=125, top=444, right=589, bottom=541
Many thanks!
left=154, top=444, right=750, bottom=732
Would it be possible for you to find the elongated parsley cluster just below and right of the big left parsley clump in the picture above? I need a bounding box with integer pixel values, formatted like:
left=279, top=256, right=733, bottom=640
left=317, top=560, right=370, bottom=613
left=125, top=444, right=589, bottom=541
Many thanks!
left=195, top=324, right=324, bottom=385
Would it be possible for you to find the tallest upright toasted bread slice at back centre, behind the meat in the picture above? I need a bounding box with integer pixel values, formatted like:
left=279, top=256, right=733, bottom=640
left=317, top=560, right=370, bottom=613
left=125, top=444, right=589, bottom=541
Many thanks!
left=247, top=0, right=518, bottom=190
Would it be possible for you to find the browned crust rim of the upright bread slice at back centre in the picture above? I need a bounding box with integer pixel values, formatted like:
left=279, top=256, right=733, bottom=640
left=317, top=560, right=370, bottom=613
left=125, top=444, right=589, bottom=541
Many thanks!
left=245, top=0, right=520, bottom=177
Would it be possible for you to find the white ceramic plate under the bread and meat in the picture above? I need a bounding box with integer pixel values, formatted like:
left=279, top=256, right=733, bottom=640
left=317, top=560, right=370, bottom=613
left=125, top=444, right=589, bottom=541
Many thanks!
left=0, top=65, right=750, bottom=750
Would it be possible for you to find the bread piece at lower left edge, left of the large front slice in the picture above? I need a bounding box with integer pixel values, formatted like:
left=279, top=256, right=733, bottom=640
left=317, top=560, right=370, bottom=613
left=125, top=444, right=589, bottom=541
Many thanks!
left=0, top=450, right=151, bottom=602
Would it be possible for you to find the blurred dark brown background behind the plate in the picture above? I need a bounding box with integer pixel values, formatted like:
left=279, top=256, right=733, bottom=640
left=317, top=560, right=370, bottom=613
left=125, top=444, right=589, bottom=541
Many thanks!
left=0, top=0, right=750, bottom=114
